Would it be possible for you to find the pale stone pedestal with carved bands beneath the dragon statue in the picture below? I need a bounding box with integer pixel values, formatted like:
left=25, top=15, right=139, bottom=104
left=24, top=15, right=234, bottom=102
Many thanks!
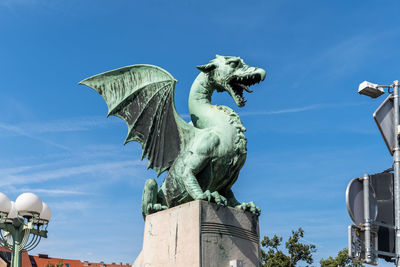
left=133, top=200, right=261, bottom=267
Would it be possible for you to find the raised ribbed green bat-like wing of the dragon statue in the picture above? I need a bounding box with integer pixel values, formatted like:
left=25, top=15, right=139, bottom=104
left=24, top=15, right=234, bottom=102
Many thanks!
left=79, top=65, right=195, bottom=176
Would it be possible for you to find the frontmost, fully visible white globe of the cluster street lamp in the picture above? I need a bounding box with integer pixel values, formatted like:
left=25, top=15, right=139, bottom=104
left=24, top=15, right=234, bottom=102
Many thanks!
left=15, top=193, right=43, bottom=217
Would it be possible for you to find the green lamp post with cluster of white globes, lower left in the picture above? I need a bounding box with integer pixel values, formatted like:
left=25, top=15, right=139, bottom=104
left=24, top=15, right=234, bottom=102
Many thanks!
left=0, top=193, right=51, bottom=267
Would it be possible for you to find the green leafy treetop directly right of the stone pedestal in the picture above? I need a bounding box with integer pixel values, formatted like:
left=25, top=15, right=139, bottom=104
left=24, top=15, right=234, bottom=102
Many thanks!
left=261, top=228, right=317, bottom=267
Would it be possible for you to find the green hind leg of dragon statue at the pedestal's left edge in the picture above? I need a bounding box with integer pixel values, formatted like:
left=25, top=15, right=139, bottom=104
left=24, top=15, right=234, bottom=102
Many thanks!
left=142, top=179, right=168, bottom=219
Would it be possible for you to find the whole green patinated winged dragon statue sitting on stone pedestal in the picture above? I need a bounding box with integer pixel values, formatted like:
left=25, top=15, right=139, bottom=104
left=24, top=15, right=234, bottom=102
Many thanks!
left=79, top=55, right=266, bottom=218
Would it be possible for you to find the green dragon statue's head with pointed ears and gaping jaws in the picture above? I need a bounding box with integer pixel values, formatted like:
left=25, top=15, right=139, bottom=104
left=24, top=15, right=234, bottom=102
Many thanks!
left=197, top=55, right=266, bottom=107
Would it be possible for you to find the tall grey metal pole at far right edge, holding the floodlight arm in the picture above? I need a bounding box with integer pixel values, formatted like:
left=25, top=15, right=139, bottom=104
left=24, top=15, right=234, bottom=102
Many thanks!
left=393, top=80, right=400, bottom=267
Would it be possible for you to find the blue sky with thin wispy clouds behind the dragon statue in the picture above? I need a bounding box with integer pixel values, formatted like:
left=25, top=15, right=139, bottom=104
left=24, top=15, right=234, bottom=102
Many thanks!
left=0, top=0, right=400, bottom=266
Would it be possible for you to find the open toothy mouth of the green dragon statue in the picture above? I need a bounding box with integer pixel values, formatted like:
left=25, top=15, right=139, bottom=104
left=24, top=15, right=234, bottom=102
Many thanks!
left=228, top=73, right=263, bottom=107
